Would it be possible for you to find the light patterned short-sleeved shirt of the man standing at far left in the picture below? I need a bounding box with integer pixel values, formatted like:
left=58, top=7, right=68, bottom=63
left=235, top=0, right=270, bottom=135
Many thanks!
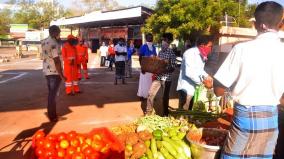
left=41, top=37, right=61, bottom=76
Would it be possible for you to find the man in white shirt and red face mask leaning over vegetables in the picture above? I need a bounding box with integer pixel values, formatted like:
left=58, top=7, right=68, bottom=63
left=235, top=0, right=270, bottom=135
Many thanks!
left=177, top=35, right=212, bottom=110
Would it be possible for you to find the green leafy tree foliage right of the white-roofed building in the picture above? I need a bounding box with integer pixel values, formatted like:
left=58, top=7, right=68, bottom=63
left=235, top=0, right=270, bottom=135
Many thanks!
left=143, top=0, right=255, bottom=40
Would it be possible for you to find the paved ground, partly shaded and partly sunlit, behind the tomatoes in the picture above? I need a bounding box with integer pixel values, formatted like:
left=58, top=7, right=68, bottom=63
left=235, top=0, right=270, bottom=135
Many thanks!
left=0, top=54, right=179, bottom=159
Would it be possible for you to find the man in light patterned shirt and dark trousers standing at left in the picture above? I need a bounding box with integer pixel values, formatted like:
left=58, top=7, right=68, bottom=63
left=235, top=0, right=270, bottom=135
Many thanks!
left=42, top=25, right=65, bottom=122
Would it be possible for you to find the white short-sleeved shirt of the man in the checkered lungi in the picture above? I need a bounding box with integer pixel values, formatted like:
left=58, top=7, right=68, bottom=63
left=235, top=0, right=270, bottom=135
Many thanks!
left=214, top=32, right=284, bottom=106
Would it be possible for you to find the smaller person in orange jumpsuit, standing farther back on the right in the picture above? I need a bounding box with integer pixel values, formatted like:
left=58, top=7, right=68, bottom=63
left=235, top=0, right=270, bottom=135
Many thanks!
left=76, top=39, right=89, bottom=80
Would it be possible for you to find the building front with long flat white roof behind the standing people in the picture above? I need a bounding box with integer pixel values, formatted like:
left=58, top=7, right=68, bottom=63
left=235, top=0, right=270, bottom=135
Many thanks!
left=51, top=7, right=153, bottom=52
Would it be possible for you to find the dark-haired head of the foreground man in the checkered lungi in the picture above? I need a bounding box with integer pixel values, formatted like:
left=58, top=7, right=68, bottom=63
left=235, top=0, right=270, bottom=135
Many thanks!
left=254, top=1, right=283, bottom=32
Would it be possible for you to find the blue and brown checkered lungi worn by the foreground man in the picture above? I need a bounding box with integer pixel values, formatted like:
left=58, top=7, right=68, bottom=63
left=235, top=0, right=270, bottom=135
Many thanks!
left=221, top=104, right=278, bottom=159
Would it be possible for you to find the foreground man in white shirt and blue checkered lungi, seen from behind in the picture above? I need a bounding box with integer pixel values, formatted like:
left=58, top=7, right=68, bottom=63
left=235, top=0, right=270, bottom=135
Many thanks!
left=214, top=1, right=284, bottom=159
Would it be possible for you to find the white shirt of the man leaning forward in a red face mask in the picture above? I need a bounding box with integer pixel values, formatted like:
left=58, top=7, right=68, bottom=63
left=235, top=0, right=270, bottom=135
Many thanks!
left=177, top=47, right=208, bottom=96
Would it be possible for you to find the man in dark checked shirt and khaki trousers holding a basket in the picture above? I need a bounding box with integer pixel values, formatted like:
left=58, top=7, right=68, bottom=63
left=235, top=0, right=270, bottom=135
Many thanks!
left=146, top=33, right=176, bottom=116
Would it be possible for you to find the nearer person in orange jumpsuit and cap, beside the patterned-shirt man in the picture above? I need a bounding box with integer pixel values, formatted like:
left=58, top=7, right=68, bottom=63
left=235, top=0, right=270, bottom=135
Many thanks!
left=62, top=35, right=80, bottom=95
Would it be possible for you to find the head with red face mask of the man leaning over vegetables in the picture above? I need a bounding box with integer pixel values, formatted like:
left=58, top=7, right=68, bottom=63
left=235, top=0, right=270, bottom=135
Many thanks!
left=196, top=35, right=213, bottom=59
